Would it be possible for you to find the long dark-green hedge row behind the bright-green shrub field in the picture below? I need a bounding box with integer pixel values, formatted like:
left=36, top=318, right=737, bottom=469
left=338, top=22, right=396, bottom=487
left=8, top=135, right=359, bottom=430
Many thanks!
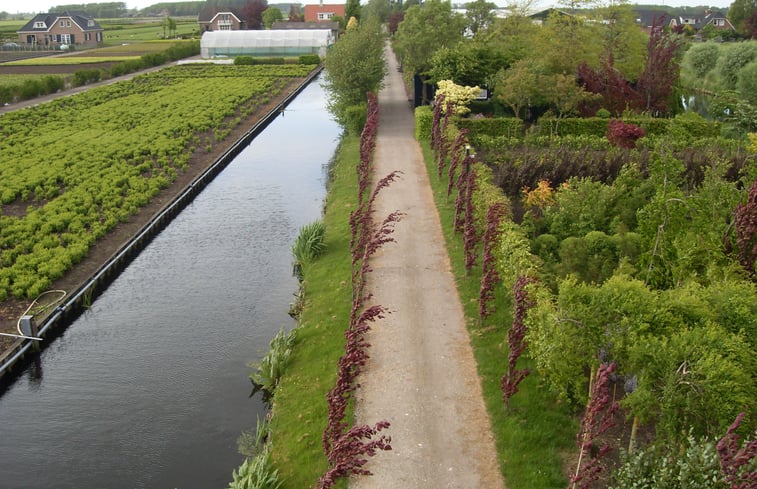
left=0, top=41, right=200, bottom=104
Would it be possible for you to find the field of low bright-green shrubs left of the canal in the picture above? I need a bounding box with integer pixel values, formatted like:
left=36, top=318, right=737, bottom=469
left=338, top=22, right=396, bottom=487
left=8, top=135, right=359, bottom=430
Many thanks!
left=0, top=65, right=313, bottom=300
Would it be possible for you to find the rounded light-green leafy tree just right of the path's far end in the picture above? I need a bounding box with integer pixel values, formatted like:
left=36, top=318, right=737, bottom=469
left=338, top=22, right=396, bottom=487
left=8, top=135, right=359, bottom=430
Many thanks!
left=394, top=0, right=465, bottom=74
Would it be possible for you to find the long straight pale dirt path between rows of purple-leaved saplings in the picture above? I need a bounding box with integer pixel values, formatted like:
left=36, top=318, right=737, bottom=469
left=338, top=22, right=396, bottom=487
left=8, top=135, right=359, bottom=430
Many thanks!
left=350, top=43, right=504, bottom=489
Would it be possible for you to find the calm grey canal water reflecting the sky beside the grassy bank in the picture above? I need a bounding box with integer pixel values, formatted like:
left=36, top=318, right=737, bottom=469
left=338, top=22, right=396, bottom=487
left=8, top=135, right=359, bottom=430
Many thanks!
left=0, top=79, right=340, bottom=489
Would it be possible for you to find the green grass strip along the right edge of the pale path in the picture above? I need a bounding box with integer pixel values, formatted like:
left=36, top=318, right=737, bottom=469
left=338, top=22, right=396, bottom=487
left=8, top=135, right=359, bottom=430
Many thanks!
left=422, top=142, right=578, bottom=489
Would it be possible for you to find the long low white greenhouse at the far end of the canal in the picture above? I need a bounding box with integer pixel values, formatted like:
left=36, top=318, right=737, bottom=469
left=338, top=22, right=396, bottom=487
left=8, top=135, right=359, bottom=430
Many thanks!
left=200, top=29, right=334, bottom=59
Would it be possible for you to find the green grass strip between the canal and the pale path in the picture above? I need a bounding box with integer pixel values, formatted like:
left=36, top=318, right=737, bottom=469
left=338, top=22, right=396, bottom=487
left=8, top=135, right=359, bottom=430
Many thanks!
left=270, top=136, right=360, bottom=489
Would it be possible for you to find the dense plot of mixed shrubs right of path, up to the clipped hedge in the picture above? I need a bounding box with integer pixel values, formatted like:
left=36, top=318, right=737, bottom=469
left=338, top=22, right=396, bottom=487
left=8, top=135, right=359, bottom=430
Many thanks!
left=416, top=102, right=757, bottom=488
